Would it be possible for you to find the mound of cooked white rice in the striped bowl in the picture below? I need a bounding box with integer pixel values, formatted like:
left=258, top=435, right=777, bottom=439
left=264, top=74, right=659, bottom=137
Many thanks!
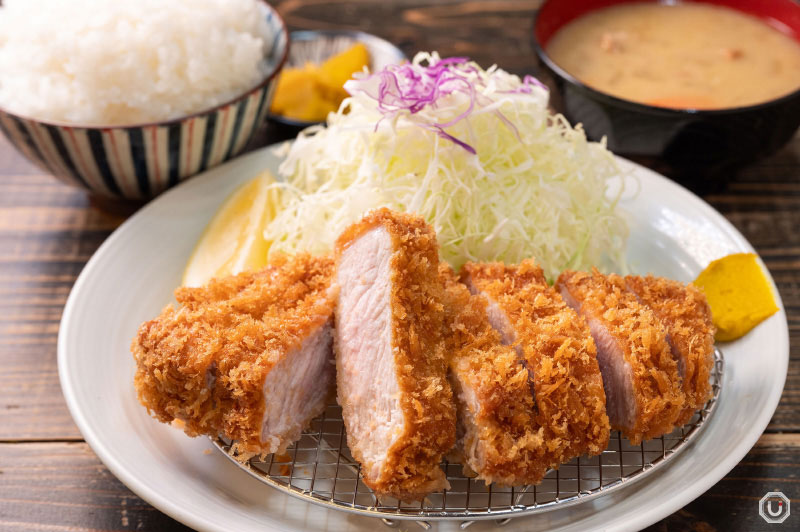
left=0, top=0, right=272, bottom=125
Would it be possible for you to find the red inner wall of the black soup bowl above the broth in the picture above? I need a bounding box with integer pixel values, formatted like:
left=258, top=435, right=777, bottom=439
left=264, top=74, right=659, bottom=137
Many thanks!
left=533, top=0, right=800, bottom=48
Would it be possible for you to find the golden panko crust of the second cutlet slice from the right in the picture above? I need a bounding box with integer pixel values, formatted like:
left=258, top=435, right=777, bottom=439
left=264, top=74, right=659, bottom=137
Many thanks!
left=557, top=269, right=685, bottom=445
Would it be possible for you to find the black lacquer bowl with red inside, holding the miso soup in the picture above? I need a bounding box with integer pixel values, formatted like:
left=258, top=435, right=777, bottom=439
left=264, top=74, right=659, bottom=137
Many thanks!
left=533, top=0, right=800, bottom=190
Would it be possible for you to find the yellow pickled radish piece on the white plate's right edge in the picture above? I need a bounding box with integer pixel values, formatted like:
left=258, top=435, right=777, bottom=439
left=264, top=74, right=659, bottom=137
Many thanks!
left=694, top=253, right=778, bottom=342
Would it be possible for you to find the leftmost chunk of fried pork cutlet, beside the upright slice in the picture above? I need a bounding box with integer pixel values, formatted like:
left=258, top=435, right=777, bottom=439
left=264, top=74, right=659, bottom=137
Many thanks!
left=131, top=255, right=335, bottom=458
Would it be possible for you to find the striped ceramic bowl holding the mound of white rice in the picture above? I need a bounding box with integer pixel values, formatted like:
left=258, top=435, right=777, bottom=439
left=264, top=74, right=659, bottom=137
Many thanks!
left=0, top=3, right=289, bottom=200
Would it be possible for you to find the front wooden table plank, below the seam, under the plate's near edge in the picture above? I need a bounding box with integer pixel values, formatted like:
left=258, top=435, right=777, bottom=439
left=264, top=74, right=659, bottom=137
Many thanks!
left=0, top=435, right=800, bottom=532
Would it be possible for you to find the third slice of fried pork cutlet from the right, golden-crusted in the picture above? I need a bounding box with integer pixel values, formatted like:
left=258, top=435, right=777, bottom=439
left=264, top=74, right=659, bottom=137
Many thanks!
left=461, top=260, right=609, bottom=467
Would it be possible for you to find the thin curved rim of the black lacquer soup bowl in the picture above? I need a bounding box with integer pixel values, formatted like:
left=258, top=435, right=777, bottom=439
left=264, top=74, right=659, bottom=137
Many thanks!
left=531, top=0, right=800, bottom=118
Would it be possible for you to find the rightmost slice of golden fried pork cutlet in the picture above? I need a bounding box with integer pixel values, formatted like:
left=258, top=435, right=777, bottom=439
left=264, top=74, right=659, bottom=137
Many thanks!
left=625, top=275, right=714, bottom=426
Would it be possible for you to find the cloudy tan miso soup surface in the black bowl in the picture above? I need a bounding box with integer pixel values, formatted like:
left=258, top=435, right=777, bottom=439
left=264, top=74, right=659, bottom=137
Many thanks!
left=546, top=3, right=800, bottom=109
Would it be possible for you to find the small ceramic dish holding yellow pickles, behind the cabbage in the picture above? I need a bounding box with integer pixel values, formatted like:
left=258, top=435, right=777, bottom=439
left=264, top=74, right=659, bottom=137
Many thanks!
left=269, top=30, right=407, bottom=138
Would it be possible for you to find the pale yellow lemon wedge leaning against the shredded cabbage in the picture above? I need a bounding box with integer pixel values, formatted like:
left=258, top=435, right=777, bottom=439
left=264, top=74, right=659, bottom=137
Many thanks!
left=182, top=171, right=281, bottom=286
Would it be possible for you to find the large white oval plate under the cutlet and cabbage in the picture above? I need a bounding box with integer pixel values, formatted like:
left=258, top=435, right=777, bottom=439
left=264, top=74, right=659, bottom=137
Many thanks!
left=58, top=148, right=789, bottom=532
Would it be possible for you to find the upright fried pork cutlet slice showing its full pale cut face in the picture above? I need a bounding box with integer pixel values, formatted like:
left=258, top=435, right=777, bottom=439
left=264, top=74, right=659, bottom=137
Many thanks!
left=335, top=209, right=456, bottom=501
